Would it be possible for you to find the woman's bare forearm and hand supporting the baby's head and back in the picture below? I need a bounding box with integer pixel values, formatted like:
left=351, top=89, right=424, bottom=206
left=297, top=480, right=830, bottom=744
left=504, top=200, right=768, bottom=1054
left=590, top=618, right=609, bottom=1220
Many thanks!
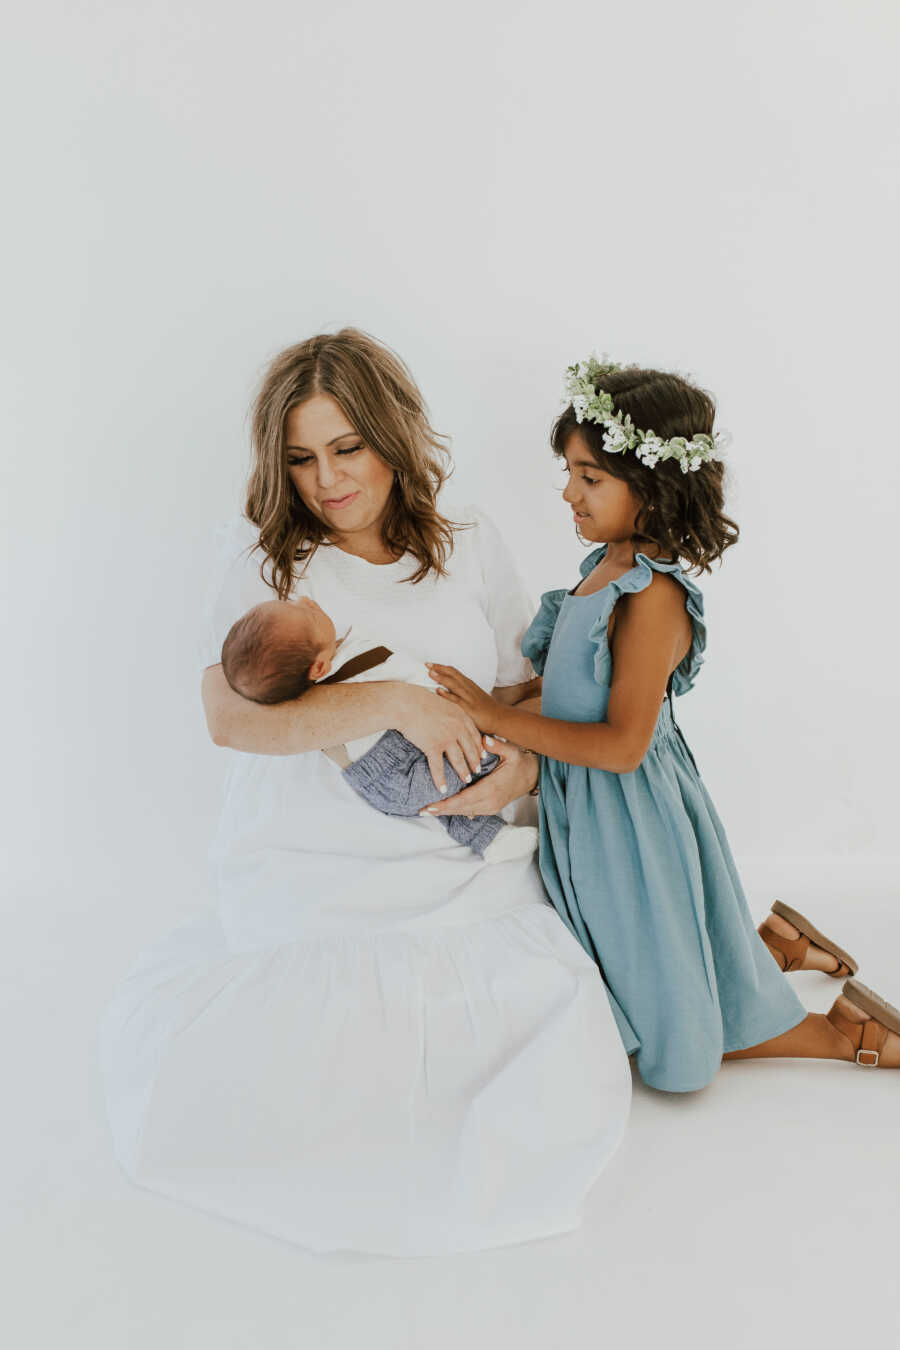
left=201, top=666, right=482, bottom=791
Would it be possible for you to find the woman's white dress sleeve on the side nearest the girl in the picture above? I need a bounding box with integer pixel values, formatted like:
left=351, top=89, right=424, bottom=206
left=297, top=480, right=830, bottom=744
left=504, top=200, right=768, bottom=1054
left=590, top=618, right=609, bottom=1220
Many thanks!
left=464, top=506, right=537, bottom=687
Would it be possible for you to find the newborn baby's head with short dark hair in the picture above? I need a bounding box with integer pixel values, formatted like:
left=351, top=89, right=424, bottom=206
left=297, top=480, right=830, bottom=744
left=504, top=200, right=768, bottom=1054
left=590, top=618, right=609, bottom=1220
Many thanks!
left=221, top=595, right=337, bottom=703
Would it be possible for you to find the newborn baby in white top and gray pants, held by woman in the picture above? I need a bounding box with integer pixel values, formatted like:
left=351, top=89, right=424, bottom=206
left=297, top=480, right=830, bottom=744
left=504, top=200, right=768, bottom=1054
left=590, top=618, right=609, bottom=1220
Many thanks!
left=221, top=595, right=537, bottom=863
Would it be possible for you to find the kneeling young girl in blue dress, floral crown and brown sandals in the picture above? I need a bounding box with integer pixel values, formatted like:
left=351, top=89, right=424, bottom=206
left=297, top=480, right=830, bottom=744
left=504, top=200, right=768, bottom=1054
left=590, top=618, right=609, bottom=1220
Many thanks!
left=429, top=358, right=900, bottom=1092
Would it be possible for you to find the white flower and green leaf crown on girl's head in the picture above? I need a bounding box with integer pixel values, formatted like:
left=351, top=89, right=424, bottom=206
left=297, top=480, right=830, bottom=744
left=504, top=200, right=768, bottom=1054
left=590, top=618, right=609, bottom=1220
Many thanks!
left=565, top=355, right=730, bottom=474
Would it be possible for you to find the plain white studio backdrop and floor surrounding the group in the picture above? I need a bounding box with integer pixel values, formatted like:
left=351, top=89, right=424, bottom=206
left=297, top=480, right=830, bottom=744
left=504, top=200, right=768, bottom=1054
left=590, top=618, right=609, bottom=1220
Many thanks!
left=0, top=0, right=900, bottom=1350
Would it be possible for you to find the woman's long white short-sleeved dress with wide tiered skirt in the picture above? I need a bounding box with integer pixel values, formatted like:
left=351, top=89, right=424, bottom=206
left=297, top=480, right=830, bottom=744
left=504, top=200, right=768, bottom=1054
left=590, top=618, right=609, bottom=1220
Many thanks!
left=100, top=508, right=630, bottom=1256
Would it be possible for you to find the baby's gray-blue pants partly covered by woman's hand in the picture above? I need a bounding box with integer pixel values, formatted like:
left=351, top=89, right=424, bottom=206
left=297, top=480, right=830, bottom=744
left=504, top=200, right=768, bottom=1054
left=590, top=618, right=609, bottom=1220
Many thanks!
left=341, top=730, right=507, bottom=855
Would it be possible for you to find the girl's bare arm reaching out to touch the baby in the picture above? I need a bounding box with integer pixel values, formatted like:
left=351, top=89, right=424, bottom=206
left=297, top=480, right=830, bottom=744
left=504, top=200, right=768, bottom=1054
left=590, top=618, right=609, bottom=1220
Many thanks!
left=429, top=575, right=690, bottom=774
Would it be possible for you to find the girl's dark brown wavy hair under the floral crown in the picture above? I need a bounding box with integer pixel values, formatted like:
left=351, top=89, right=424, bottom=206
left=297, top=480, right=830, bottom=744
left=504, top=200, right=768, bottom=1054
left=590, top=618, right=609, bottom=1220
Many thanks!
left=551, top=366, right=741, bottom=572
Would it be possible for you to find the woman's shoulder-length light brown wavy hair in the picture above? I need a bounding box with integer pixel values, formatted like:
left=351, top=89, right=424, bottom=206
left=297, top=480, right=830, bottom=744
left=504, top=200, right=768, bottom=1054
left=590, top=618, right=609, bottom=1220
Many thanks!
left=244, top=328, right=468, bottom=599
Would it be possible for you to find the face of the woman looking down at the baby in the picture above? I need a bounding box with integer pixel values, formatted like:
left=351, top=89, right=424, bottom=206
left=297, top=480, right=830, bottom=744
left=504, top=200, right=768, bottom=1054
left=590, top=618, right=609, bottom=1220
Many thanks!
left=285, top=394, right=394, bottom=543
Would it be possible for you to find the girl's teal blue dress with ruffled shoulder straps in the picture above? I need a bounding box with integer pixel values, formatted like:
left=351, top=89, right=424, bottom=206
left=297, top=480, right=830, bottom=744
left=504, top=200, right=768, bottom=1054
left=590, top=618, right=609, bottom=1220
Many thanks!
left=522, top=545, right=807, bottom=1092
